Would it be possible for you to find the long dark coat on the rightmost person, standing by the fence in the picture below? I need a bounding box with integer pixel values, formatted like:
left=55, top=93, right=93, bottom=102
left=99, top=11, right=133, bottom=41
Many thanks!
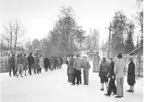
left=127, top=61, right=135, bottom=85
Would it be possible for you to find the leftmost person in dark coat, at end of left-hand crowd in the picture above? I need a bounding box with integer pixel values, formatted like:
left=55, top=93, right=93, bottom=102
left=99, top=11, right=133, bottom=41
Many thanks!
left=8, top=54, right=16, bottom=77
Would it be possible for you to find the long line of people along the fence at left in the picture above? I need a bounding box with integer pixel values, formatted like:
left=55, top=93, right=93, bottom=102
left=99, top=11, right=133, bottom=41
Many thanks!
left=8, top=53, right=63, bottom=77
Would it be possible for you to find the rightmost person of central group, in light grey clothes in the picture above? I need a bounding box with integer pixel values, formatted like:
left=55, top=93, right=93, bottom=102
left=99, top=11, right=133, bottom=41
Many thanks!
left=81, top=57, right=90, bottom=85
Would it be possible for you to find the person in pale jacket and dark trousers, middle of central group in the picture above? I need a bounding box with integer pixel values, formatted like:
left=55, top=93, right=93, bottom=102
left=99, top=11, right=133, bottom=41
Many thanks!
left=71, top=54, right=82, bottom=85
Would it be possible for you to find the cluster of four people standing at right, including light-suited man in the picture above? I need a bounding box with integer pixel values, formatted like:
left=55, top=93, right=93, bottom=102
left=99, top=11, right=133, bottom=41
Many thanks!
left=99, top=54, right=135, bottom=98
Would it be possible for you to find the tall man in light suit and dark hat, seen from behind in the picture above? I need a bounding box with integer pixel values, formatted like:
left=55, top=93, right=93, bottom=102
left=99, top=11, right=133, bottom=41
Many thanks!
left=114, top=54, right=125, bottom=98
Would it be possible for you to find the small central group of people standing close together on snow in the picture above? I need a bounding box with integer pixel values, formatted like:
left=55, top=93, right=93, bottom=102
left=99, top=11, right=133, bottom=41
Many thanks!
left=66, top=54, right=90, bottom=85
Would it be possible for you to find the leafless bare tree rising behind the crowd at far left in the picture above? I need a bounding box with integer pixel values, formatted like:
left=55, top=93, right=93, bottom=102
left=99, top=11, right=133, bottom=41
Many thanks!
left=2, top=21, right=24, bottom=54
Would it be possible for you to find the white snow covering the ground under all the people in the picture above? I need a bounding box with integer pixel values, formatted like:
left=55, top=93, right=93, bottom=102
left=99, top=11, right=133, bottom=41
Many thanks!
left=0, top=65, right=143, bottom=102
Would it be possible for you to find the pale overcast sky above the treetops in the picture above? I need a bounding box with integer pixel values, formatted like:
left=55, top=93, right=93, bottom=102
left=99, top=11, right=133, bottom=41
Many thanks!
left=0, top=0, right=137, bottom=44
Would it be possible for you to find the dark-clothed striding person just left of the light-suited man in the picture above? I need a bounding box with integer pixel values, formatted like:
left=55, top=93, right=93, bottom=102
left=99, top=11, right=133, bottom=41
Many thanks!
left=105, top=58, right=116, bottom=96
